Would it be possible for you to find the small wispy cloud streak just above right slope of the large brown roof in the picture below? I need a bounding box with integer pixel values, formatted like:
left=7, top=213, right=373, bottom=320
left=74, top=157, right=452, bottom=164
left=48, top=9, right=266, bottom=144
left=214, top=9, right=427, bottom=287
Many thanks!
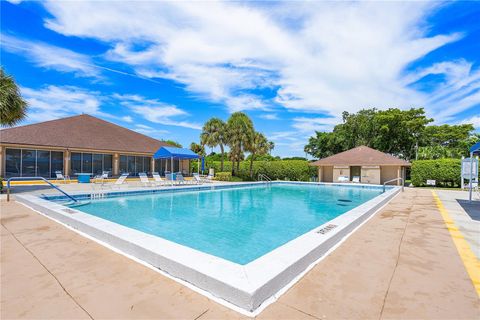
left=113, top=94, right=202, bottom=131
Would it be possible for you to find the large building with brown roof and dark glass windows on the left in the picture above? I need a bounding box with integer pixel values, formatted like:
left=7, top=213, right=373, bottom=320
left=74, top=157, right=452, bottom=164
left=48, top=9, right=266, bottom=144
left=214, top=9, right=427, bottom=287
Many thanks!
left=0, top=114, right=189, bottom=178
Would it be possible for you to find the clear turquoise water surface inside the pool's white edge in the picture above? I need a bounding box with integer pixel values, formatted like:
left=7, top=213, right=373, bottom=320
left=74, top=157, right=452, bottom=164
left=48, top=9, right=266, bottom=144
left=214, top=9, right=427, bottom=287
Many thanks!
left=64, top=183, right=381, bottom=264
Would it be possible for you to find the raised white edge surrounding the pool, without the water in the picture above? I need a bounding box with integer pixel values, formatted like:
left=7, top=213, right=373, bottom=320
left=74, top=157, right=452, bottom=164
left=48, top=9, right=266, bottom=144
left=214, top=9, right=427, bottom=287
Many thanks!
left=16, top=182, right=400, bottom=316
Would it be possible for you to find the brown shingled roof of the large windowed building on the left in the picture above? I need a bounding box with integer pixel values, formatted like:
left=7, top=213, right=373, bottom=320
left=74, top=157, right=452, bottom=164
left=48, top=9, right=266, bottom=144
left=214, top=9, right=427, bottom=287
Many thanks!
left=0, top=114, right=169, bottom=154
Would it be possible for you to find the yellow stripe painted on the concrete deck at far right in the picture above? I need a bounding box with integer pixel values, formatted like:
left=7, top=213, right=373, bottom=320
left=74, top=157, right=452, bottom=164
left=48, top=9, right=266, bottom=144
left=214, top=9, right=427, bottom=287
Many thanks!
left=432, top=190, right=480, bottom=297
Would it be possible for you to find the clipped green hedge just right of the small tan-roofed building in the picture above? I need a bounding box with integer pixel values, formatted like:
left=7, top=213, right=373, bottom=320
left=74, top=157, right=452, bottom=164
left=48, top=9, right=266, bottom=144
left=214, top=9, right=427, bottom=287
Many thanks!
left=411, top=159, right=461, bottom=187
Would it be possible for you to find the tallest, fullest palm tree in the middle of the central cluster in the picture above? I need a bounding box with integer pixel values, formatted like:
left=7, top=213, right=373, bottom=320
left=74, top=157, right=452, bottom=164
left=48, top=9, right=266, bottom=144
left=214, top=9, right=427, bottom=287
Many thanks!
left=226, top=112, right=254, bottom=175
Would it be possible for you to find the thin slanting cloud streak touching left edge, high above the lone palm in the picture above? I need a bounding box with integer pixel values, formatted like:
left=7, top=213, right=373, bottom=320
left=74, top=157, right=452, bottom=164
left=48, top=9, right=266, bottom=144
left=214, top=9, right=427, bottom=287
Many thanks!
left=1, top=33, right=99, bottom=77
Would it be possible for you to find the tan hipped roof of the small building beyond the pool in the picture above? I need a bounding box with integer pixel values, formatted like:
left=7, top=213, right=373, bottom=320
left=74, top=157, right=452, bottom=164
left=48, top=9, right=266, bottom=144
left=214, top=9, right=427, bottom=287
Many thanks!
left=310, top=146, right=410, bottom=166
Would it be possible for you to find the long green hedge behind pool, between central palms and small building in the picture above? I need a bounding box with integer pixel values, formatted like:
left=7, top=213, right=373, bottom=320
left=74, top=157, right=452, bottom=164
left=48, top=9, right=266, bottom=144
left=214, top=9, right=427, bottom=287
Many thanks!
left=192, top=160, right=317, bottom=181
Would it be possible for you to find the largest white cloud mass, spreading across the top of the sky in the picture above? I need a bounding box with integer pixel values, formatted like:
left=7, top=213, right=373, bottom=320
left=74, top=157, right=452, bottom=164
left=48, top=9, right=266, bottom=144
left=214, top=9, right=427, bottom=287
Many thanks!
left=38, top=1, right=471, bottom=117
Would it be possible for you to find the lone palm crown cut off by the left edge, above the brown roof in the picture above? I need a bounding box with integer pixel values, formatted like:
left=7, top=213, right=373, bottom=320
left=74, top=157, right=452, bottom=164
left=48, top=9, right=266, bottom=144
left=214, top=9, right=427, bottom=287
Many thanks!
left=0, top=69, right=28, bottom=126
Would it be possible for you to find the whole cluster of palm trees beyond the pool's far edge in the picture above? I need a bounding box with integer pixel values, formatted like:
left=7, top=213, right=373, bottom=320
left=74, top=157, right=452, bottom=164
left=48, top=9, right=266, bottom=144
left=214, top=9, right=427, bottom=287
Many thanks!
left=196, top=112, right=275, bottom=177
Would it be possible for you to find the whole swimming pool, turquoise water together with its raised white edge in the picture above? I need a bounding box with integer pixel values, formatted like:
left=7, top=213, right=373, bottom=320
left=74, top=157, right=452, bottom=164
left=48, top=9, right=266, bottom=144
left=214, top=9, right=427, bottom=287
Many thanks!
left=16, top=181, right=400, bottom=316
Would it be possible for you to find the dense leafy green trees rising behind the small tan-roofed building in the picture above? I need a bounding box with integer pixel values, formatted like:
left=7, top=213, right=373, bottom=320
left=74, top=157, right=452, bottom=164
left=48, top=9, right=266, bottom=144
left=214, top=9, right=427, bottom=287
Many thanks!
left=304, top=108, right=480, bottom=160
